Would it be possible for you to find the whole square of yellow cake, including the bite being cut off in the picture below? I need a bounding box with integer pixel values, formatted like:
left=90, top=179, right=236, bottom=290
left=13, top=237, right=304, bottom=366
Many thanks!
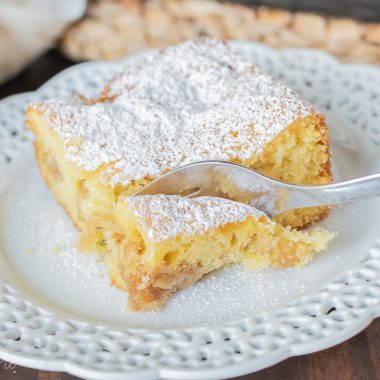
left=26, top=39, right=332, bottom=309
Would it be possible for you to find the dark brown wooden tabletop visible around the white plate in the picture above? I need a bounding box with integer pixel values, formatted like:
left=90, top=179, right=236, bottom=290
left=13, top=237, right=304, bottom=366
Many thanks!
left=0, top=51, right=380, bottom=380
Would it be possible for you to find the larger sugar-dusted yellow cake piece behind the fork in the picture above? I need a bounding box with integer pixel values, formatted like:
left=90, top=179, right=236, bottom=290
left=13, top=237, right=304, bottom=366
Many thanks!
left=26, top=39, right=331, bottom=250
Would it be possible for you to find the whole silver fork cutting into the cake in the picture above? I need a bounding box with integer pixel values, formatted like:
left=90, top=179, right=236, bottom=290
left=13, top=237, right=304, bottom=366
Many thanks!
left=134, top=161, right=380, bottom=217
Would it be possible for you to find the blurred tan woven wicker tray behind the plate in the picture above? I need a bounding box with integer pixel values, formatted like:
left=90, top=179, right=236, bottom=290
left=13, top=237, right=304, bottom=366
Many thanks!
left=60, top=0, right=380, bottom=64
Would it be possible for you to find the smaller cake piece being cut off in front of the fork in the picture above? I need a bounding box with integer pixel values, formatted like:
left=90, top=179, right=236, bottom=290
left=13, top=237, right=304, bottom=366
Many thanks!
left=104, top=195, right=333, bottom=310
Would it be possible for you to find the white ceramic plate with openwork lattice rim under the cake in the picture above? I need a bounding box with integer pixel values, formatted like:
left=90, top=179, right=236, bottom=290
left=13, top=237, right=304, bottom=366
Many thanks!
left=0, top=41, right=380, bottom=380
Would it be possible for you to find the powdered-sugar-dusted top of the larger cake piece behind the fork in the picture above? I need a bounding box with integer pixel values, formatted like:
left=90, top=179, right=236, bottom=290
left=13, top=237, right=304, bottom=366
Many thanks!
left=32, top=39, right=315, bottom=186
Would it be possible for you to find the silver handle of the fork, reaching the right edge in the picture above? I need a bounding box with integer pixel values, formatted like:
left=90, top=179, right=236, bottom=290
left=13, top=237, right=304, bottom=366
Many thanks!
left=284, top=173, right=380, bottom=213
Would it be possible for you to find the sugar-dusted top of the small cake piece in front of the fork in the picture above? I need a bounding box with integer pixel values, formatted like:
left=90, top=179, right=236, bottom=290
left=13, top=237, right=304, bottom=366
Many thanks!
left=123, top=195, right=273, bottom=243
